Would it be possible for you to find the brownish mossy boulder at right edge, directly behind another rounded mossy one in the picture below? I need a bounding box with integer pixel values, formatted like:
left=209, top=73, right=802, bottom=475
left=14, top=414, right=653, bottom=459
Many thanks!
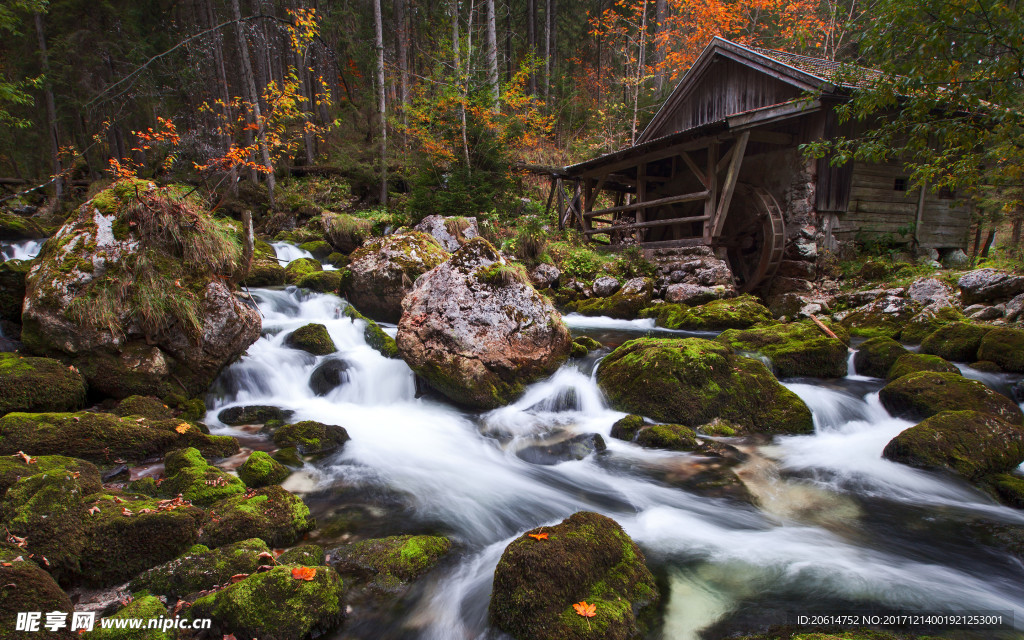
left=879, top=372, right=1024, bottom=424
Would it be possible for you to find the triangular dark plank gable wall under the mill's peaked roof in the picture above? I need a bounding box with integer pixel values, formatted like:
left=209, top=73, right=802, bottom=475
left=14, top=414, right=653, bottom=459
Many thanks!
left=651, top=58, right=801, bottom=137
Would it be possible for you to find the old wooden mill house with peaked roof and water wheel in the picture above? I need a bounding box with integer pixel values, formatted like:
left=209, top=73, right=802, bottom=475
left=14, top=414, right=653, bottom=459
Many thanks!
left=549, top=38, right=970, bottom=291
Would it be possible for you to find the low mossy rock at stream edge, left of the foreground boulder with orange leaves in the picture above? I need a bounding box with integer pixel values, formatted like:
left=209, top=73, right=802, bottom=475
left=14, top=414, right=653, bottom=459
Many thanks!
left=331, top=536, right=452, bottom=592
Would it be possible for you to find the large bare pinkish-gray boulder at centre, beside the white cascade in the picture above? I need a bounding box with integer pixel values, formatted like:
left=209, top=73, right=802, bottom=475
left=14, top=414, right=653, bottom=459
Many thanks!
left=397, top=238, right=571, bottom=409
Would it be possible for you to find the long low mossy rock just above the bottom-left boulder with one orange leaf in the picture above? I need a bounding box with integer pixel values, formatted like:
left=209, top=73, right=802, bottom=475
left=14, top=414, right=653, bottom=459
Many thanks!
left=128, top=538, right=274, bottom=598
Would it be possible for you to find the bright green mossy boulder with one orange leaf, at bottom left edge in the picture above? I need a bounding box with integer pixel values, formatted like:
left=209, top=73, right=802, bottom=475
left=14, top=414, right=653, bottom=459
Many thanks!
left=185, top=565, right=345, bottom=640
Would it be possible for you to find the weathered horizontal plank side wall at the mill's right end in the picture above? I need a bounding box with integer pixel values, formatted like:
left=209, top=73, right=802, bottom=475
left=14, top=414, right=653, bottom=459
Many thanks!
left=836, top=162, right=971, bottom=248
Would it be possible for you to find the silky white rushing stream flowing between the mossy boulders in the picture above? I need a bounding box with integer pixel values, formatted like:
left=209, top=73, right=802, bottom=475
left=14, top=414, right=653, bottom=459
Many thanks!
left=208, top=286, right=1024, bottom=640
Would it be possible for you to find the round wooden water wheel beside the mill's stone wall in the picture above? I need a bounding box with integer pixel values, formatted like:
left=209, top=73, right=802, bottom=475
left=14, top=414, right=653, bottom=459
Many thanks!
left=716, top=183, right=785, bottom=292
